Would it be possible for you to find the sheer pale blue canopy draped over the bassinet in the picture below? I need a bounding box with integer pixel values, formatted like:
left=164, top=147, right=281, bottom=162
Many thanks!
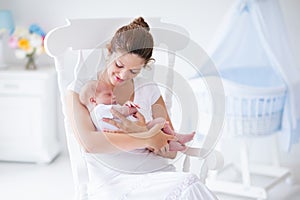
left=209, top=0, right=300, bottom=149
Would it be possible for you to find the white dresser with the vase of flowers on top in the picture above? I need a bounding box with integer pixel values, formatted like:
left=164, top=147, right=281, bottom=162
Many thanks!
left=0, top=67, right=60, bottom=163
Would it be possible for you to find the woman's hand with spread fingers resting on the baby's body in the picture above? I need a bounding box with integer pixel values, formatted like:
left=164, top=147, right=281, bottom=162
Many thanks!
left=103, top=108, right=148, bottom=133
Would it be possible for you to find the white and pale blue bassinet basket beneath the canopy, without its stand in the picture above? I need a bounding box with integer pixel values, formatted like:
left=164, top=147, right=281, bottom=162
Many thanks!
left=221, top=67, right=287, bottom=136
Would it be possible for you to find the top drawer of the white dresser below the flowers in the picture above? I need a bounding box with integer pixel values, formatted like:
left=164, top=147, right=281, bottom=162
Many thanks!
left=0, top=80, right=46, bottom=94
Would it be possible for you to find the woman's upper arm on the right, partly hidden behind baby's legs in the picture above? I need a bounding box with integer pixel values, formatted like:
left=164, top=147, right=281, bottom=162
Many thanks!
left=152, top=96, right=177, bottom=159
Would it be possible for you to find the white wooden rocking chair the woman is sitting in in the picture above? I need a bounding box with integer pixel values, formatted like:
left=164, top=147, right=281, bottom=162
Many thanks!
left=45, top=18, right=223, bottom=199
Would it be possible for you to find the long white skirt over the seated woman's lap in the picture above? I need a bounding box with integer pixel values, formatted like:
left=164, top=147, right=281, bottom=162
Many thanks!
left=89, top=172, right=217, bottom=200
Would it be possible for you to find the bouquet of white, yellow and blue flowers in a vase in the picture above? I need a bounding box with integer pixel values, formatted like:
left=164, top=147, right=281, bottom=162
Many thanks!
left=8, top=24, right=46, bottom=69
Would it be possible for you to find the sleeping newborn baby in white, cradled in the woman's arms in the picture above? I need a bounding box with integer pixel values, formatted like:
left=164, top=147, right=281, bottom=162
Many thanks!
left=79, top=80, right=195, bottom=151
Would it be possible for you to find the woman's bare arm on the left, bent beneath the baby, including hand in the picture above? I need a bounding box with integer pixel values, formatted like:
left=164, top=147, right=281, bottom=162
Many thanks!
left=66, top=91, right=172, bottom=153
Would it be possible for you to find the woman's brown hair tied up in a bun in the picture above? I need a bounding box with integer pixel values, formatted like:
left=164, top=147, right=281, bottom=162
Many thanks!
left=108, top=17, right=154, bottom=64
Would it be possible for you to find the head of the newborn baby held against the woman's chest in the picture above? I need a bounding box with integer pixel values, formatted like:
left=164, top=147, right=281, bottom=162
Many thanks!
left=79, top=80, right=116, bottom=111
